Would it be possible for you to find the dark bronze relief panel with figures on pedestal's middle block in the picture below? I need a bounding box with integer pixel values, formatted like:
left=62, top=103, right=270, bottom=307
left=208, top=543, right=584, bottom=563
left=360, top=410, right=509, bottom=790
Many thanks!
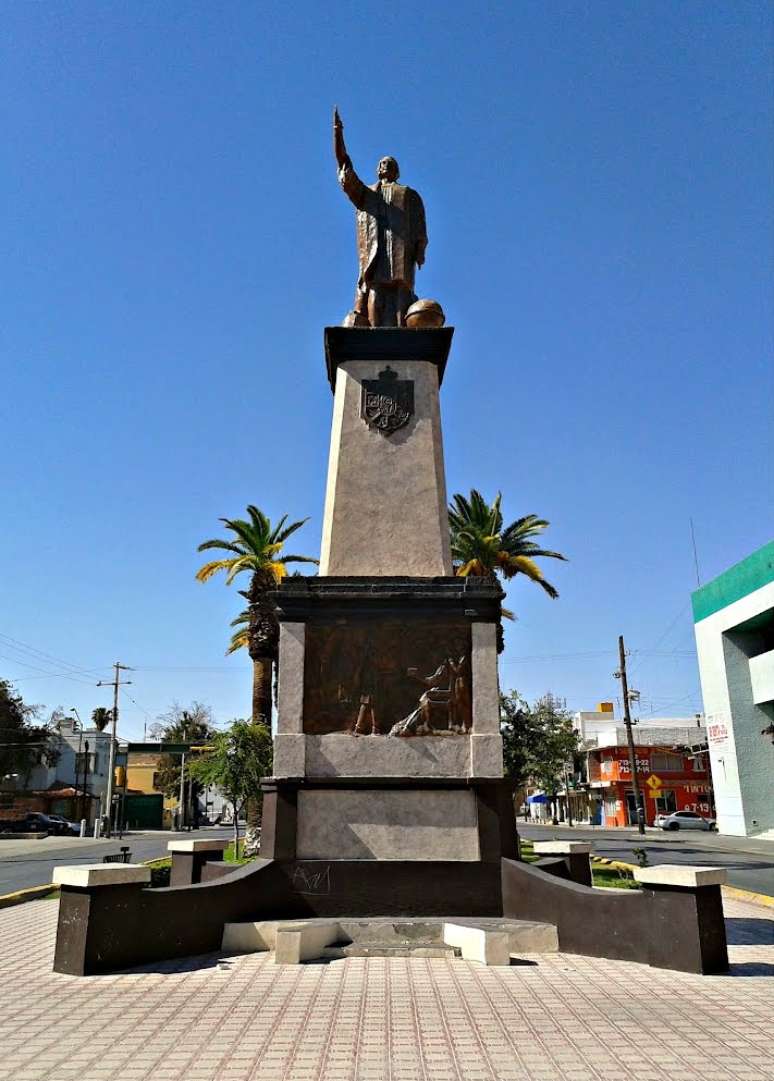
left=304, top=619, right=472, bottom=736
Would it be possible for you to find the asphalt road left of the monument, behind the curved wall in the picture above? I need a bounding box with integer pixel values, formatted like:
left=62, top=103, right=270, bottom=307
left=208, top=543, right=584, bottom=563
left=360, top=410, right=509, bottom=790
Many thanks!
left=0, top=827, right=232, bottom=896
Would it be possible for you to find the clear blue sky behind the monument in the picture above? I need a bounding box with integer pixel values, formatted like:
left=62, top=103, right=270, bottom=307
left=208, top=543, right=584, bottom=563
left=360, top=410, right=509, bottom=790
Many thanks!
left=0, top=0, right=774, bottom=737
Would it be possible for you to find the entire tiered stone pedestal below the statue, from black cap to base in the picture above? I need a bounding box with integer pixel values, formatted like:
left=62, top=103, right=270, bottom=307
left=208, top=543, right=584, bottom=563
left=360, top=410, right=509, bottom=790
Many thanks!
left=262, top=328, right=516, bottom=916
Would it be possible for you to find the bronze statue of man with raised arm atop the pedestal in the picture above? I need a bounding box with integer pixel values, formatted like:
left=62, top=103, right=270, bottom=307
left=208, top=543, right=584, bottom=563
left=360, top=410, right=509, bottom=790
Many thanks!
left=333, top=109, right=427, bottom=326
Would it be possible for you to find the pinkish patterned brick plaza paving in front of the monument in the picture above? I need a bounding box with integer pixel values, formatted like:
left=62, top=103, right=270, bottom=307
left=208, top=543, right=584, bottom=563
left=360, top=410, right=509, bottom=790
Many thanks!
left=0, top=900, right=774, bottom=1081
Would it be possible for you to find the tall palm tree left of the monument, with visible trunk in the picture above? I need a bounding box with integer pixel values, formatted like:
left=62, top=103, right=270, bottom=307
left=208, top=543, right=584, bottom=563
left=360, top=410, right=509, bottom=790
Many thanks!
left=197, top=504, right=317, bottom=728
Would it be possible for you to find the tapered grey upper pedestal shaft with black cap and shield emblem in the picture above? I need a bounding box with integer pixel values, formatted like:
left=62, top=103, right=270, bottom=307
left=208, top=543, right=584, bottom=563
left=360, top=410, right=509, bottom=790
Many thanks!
left=320, top=326, right=452, bottom=577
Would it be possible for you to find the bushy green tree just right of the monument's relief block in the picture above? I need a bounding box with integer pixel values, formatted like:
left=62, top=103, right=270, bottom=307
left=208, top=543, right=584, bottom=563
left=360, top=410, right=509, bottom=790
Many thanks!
left=501, top=691, right=578, bottom=817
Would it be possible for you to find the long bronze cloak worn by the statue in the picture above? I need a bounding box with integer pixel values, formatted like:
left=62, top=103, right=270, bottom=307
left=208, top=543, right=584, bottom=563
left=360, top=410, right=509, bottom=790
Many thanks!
left=339, top=166, right=427, bottom=292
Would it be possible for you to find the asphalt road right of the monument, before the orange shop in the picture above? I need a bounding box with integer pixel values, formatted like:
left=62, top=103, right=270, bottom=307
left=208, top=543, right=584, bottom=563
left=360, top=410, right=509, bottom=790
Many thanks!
left=519, top=822, right=774, bottom=896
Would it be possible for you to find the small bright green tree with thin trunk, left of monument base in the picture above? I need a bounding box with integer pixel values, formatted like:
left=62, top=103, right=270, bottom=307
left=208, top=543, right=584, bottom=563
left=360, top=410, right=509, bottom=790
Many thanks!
left=190, top=720, right=272, bottom=854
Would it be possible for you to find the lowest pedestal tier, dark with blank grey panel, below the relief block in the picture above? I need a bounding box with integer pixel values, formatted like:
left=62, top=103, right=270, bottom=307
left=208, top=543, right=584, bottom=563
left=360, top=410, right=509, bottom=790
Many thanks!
left=261, top=777, right=518, bottom=916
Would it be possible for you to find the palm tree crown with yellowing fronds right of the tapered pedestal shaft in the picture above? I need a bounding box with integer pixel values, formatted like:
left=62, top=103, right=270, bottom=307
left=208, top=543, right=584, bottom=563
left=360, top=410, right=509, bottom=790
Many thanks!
left=449, top=489, right=566, bottom=601
